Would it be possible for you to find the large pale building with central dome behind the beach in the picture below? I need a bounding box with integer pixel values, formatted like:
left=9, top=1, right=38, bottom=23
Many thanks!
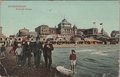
left=35, top=19, right=98, bottom=40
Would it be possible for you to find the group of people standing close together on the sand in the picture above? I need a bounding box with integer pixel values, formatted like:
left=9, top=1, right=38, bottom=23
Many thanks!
left=9, top=38, right=54, bottom=68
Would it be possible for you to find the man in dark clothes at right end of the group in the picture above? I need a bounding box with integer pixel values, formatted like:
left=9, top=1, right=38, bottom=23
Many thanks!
left=43, top=41, right=54, bottom=69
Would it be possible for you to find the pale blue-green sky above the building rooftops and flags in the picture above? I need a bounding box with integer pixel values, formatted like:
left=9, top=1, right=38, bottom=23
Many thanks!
left=0, top=1, right=119, bottom=36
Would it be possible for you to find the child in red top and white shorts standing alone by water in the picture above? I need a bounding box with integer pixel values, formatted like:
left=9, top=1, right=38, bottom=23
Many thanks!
left=69, top=50, right=76, bottom=73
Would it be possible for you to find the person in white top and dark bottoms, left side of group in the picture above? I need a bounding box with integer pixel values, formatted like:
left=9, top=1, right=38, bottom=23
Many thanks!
left=15, top=44, right=22, bottom=66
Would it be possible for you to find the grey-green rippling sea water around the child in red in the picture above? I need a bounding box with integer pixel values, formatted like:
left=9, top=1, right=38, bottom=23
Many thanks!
left=52, top=45, right=119, bottom=77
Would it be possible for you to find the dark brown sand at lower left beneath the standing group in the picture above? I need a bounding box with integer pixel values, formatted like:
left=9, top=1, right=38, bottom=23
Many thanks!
left=0, top=48, right=69, bottom=77
